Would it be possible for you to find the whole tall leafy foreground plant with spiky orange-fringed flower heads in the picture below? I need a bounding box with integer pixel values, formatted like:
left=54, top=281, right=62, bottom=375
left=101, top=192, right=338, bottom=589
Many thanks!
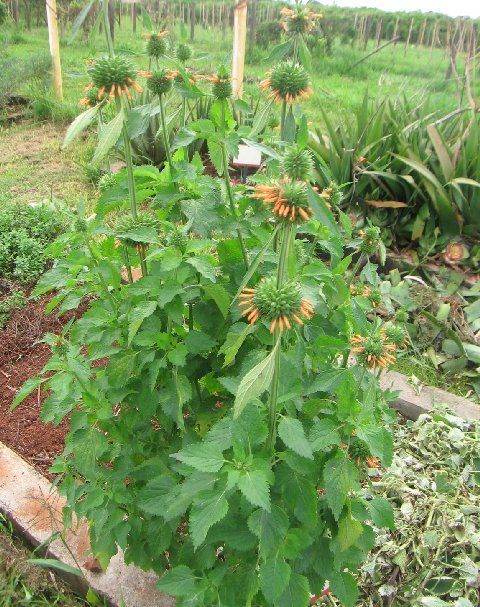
left=14, top=7, right=396, bottom=607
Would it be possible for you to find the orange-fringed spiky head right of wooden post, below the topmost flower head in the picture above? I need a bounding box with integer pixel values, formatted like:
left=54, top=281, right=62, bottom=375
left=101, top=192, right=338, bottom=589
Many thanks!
left=260, top=61, right=313, bottom=105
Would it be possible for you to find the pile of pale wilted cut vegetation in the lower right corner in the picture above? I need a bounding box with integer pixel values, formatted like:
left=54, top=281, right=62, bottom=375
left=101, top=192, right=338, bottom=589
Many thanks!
left=359, top=406, right=480, bottom=607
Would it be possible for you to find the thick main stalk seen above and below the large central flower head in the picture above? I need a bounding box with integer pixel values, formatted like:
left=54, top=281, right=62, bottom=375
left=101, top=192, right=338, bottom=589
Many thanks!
left=267, top=224, right=293, bottom=453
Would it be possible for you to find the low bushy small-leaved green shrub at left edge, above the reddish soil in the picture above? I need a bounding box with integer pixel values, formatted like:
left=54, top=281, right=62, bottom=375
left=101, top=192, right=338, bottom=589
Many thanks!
left=0, top=204, right=61, bottom=284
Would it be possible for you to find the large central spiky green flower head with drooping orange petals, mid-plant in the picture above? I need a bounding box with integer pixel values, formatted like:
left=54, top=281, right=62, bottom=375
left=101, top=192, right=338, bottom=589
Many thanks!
left=239, top=278, right=315, bottom=333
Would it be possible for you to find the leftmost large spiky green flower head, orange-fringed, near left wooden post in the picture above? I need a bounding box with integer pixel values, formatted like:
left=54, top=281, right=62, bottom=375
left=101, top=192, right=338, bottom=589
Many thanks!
left=88, top=55, right=142, bottom=97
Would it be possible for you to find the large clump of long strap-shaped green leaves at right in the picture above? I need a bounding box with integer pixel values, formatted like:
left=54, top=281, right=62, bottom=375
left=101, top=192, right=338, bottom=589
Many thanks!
left=311, top=97, right=480, bottom=254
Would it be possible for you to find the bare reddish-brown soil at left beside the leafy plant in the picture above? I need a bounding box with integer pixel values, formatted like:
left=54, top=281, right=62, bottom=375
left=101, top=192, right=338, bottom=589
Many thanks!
left=0, top=297, right=79, bottom=478
